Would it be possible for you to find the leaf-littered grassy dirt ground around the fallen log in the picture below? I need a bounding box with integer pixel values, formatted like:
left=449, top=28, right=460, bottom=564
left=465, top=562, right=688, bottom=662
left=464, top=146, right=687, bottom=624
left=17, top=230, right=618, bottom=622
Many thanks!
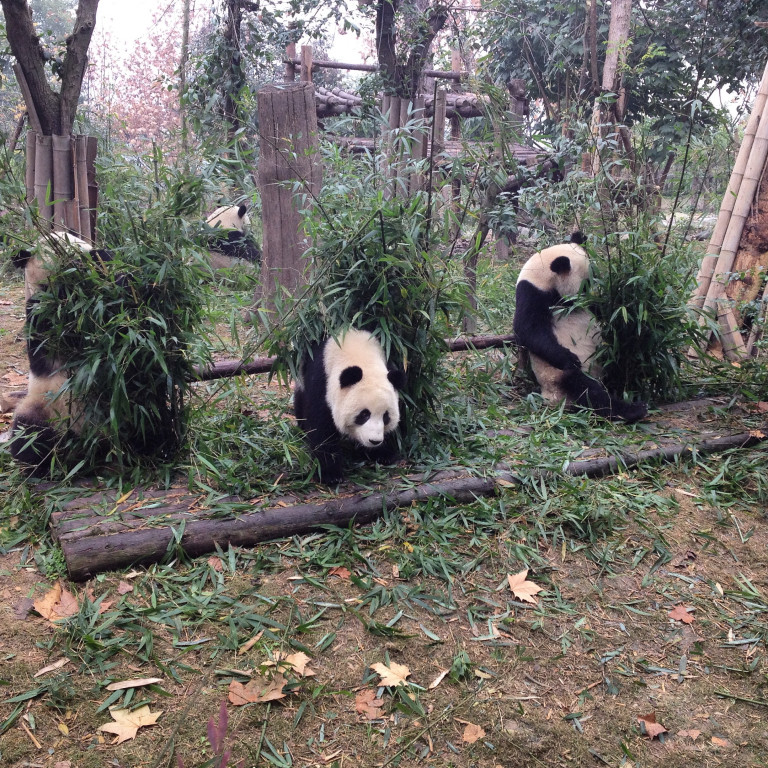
left=0, top=260, right=768, bottom=768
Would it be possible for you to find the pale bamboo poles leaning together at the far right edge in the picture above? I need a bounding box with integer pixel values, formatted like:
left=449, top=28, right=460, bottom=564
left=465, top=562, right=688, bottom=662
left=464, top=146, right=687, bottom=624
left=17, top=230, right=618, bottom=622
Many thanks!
left=691, top=60, right=768, bottom=360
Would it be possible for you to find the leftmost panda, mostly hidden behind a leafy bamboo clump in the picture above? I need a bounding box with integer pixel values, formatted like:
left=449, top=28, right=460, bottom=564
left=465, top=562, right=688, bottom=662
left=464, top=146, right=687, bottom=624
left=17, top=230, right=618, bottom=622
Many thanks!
left=10, top=232, right=112, bottom=471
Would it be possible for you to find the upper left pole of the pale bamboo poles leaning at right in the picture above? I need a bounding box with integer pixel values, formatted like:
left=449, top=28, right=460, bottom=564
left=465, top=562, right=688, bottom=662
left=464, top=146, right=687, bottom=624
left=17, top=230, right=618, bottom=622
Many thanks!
left=691, top=64, right=768, bottom=307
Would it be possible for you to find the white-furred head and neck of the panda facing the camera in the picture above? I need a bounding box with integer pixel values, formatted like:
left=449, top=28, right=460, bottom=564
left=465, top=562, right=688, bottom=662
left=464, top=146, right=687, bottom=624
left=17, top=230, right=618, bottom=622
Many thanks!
left=324, top=329, right=400, bottom=448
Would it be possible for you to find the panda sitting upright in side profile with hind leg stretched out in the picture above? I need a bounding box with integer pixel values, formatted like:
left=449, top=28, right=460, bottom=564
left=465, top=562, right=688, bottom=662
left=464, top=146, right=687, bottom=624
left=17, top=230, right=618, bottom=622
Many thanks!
left=514, top=232, right=648, bottom=422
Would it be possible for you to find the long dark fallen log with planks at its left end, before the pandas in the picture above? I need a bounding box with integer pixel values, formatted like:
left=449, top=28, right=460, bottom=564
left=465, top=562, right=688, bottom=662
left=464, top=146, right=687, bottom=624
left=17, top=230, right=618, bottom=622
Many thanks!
left=51, top=432, right=765, bottom=581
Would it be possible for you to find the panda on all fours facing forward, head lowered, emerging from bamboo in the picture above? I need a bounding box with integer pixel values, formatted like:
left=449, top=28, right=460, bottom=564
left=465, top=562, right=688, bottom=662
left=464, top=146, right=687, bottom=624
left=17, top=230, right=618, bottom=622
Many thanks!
left=294, top=328, right=405, bottom=484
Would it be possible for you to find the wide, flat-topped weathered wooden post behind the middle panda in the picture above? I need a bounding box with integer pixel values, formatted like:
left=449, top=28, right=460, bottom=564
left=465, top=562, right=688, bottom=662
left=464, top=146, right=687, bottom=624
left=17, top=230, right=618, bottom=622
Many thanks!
left=255, top=82, right=322, bottom=311
